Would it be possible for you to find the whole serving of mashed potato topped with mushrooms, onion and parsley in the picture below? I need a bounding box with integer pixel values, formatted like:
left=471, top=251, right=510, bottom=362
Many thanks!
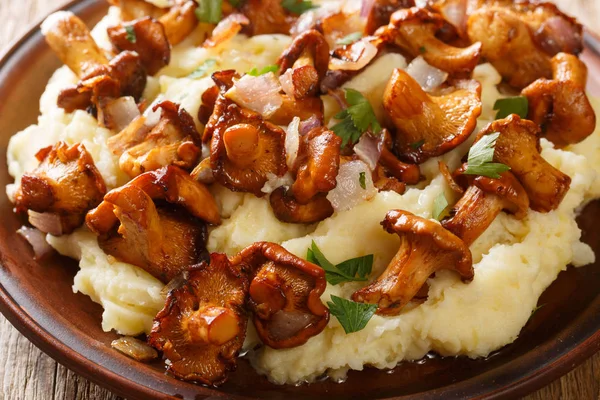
left=7, top=0, right=600, bottom=385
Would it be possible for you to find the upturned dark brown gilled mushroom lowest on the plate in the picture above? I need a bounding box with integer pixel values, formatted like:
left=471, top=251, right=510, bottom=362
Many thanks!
left=148, top=254, right=248, bottom=385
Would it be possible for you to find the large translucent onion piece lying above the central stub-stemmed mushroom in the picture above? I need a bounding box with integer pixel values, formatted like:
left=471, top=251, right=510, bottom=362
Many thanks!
left=225, top=72, right=283, bottom=118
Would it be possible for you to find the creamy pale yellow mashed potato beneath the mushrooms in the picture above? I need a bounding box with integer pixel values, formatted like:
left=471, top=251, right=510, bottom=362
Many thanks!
left=7, top=1, right=600, bottom=383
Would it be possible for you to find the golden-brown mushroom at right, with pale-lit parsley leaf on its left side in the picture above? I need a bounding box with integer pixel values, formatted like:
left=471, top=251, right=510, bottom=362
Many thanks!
left=476, top=114, right=571, bottom=212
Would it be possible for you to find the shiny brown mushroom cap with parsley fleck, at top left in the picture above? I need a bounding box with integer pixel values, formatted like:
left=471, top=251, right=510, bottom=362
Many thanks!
left=107, top=17, right=171, bottom=75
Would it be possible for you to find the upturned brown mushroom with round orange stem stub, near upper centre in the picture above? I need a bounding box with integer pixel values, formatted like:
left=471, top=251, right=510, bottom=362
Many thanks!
left=204, top=96, right=287, bottom=196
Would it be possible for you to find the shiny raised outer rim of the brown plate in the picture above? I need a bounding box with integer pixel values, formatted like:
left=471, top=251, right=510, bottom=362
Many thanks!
left=0, top=0, right=600, bottom=399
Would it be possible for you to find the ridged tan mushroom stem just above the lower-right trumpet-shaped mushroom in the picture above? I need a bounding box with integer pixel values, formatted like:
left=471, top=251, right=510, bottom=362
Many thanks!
left=442, top=185, right=504, bottom=246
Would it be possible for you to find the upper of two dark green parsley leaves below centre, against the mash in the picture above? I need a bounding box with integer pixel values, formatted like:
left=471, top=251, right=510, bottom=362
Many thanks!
left=306, top=240, right=373, bottom=285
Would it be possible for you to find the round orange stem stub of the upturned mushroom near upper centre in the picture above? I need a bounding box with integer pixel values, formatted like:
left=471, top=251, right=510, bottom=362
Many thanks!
left=223, top=124, right=260, bottom=167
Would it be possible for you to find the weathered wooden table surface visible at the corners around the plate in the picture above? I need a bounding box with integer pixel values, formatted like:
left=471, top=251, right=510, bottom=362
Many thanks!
left=0, top=0, right=600, bottom=400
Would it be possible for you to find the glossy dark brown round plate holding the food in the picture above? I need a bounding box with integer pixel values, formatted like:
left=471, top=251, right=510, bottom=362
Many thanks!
left=0, top=0, right=600, bottom=399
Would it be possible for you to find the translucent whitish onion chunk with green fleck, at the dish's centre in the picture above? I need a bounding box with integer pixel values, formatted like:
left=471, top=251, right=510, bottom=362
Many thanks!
left=327, top=160, right=377, bottom=212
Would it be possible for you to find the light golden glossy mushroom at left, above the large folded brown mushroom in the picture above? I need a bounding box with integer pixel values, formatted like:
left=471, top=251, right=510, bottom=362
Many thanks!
left=108, top=101, right=202, bottom=178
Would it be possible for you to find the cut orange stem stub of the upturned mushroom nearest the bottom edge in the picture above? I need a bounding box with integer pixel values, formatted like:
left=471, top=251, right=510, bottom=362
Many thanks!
left=187, top=306, right=240, bottom=346
